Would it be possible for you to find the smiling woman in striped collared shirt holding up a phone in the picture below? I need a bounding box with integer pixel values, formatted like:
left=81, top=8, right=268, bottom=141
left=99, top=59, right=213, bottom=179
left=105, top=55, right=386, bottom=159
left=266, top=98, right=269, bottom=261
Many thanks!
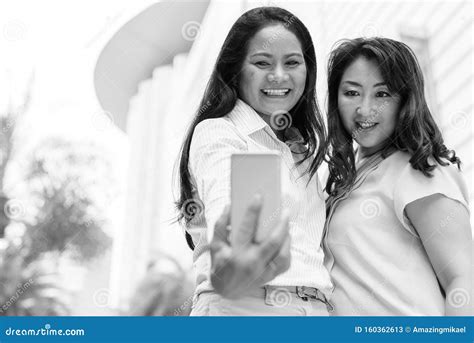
left=177, top=7, right=332, bottom=315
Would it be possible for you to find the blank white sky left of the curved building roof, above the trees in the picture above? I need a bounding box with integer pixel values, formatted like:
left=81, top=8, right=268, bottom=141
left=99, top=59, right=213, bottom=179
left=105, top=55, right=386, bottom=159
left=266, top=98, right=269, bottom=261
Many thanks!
left=0, top=0, right=158, bottom=239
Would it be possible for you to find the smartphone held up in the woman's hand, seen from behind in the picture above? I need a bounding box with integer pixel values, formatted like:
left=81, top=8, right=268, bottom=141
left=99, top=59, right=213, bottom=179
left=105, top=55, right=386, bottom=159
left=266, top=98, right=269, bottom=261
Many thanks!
left=230, top=152, right=282, bottom=246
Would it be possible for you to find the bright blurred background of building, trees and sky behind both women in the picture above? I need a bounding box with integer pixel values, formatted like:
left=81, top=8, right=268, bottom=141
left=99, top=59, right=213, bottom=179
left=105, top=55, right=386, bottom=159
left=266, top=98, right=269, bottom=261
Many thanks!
left=0, top=0, right=474, bottom=315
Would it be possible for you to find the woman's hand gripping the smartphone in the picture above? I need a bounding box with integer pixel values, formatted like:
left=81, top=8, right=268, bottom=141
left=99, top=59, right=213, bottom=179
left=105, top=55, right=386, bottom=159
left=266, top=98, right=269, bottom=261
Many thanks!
left=211, top=198, right=291, bottom=298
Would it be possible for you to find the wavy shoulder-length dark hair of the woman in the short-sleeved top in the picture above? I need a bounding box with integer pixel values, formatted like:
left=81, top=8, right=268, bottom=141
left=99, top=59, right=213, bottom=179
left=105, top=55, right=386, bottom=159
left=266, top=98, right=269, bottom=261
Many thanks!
left=326, top=37, right=461, bottom=194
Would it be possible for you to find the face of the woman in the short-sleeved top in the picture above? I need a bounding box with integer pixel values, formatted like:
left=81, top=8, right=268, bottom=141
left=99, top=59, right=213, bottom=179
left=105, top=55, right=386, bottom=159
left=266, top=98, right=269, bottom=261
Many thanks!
left=338, top=56, right=400, bottom=156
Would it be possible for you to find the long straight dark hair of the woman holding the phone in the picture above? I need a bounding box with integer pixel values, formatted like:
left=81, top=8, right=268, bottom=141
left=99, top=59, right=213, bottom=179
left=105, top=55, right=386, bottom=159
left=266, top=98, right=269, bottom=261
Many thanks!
left=176, top=7, right=327, bottom=247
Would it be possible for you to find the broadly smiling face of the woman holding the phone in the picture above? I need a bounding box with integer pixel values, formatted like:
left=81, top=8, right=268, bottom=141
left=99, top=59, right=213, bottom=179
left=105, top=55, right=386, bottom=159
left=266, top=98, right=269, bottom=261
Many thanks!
left=239, top=24, right=306, bottom=121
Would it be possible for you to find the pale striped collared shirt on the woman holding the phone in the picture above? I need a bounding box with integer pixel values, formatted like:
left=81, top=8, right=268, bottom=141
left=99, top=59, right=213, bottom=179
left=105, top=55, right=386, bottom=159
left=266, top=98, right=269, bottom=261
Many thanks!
left=186, top=99, right=332, bottom=296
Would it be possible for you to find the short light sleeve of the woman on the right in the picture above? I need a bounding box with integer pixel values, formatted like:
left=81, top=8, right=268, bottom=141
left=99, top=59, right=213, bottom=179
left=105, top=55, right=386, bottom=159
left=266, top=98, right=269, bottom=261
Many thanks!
left=393, top=163, right=469, bottom=237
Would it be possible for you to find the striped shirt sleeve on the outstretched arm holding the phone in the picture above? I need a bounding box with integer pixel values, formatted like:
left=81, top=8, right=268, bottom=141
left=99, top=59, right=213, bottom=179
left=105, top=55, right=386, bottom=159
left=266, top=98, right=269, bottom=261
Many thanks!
left=189, top=118, right=247, bottom=242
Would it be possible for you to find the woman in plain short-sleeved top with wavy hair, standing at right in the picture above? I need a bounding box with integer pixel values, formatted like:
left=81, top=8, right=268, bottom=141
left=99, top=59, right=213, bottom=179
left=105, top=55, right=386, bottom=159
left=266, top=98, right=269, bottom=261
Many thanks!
left=324, top=38, right=472, bottom=315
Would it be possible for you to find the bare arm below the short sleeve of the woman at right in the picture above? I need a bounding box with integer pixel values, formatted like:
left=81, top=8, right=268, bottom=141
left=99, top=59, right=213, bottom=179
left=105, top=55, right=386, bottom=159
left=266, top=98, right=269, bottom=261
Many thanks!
left=405, top=194, right=472, bottom=316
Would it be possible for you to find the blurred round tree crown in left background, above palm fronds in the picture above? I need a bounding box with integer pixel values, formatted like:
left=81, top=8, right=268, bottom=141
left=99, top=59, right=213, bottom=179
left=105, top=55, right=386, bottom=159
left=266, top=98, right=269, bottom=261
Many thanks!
left=22, top=138, right=114, bottom=261
